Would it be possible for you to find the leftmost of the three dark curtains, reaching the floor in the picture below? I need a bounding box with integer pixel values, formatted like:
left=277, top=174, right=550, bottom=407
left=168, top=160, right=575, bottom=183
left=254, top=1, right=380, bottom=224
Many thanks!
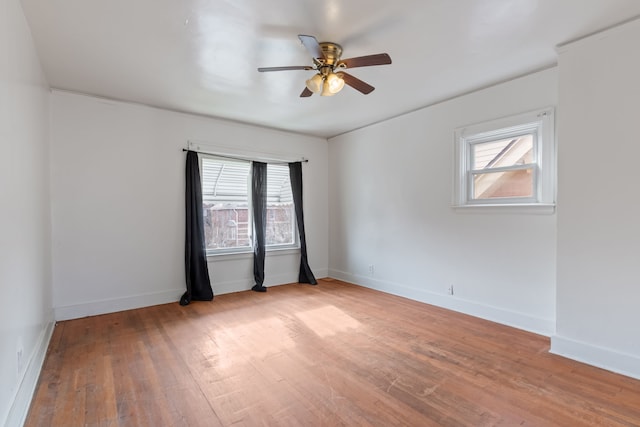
left=180, top=151, right=213, bottom=305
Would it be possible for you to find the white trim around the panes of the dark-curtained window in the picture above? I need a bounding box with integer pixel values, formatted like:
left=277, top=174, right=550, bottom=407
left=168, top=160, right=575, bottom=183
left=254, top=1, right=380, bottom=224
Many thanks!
left=198, top=154, right=300, bottom=259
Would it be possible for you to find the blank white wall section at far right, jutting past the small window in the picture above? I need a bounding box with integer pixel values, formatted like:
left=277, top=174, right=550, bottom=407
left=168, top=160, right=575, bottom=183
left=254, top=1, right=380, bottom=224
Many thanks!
left=552, top=21, right=640, bottom=378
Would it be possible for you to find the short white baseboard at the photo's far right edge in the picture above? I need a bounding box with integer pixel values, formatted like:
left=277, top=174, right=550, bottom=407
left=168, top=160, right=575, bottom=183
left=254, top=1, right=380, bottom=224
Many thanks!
left=549, top=335, right=640, bottom=380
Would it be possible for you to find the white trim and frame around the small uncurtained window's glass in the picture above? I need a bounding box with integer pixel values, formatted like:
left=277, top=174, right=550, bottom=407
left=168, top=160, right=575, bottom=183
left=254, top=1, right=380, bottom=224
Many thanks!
left=452, top=107, right=556, bottom=213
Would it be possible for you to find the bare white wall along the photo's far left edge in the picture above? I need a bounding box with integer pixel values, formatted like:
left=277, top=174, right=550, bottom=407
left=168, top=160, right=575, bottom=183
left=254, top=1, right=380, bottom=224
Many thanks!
left=0, top=0, right=53, bottom=426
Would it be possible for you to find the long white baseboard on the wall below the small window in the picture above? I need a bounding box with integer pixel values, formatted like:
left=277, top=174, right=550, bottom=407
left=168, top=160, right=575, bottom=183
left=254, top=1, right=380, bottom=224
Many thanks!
left=329, top=269, right=555, bottom=337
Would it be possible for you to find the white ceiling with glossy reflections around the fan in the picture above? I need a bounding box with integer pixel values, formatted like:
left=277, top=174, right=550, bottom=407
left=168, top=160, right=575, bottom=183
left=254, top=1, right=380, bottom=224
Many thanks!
left=17, top=0, right=640, bottom=137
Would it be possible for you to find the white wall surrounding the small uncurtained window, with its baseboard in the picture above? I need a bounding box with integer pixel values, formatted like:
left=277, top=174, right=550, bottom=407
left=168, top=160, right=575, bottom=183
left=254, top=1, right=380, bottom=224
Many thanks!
left=329, top=69, right=557, bottom=335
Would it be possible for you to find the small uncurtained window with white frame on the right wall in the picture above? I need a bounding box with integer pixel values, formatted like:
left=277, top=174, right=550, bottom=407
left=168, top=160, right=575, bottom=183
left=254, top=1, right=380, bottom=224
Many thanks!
left=454, top=108, right=555, bottom=208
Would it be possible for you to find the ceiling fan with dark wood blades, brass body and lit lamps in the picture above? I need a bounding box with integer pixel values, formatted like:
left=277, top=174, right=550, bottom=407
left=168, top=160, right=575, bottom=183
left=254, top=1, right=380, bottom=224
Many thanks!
left=258, top=34, right=391, bottom=98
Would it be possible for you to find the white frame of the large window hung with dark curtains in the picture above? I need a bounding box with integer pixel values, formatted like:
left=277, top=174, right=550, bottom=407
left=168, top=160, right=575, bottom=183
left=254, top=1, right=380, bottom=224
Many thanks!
left=198, top=152, right=300, bottom=257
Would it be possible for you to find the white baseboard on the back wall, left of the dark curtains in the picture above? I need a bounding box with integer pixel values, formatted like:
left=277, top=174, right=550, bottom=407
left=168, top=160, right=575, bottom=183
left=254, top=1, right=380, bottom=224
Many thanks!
left=53, top=289, right=184, bottom=321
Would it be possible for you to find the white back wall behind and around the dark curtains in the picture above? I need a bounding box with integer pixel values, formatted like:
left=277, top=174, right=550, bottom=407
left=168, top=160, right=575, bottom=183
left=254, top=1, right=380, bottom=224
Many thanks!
left=51, top=91, right=328, bottom=319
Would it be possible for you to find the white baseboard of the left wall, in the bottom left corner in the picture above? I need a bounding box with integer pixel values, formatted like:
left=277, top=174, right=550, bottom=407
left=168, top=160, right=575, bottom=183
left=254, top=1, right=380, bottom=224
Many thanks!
left=5, top=322, right=55, bottom=427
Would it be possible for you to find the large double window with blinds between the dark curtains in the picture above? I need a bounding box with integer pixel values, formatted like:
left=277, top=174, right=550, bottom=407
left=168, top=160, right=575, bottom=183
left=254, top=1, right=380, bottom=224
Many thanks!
left=200, top=155, right=297, bottom=255
